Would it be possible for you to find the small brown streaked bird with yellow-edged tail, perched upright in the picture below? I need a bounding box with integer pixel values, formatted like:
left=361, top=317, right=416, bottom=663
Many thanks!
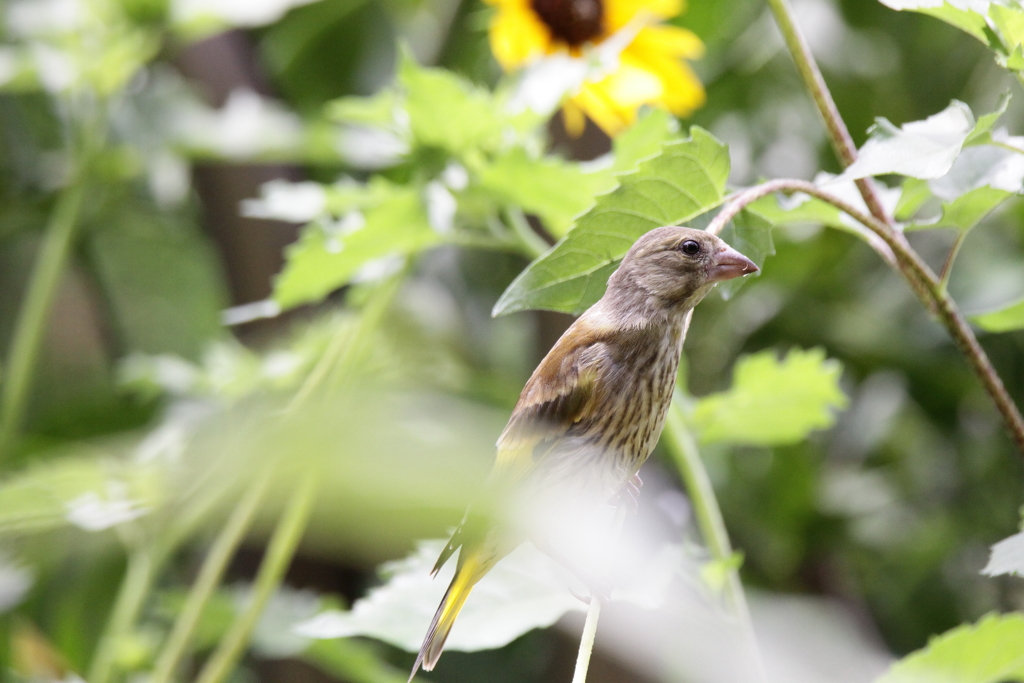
left=410, top=226, right=758, bottom=681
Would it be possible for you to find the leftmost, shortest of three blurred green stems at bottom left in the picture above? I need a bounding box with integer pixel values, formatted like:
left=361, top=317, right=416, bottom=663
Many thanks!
left=89, top=543, right=156, bottom=683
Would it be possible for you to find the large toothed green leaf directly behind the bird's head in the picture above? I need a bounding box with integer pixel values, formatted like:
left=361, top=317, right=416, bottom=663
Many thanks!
left=494, top=126, right=729, bottom=315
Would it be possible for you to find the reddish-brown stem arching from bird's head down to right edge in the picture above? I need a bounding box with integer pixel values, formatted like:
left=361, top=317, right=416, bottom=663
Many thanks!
left=708, top=179, right=1024, bottom=456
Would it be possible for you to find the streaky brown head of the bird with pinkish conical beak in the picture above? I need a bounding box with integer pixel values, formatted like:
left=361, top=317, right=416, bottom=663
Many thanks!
left=608, top=225, right=759, bottom=321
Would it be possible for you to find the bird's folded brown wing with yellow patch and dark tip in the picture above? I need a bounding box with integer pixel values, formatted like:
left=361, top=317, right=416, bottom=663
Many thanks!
left=425, top=321, right=604, bottom=573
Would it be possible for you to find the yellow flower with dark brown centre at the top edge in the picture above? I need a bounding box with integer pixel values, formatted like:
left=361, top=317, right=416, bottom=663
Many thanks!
left=486, top=0, right=705, bottom=135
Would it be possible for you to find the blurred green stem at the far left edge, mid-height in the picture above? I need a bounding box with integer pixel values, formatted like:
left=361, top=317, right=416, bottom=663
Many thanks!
left=0, top=177, right=85, bottom=458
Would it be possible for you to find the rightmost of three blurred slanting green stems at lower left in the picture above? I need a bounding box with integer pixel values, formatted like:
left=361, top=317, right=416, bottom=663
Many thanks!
left=196, top=471, right=319, bottom=683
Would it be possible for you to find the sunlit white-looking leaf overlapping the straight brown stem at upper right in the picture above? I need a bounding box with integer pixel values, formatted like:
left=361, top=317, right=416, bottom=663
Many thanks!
left=839, top=99, right=976, bottom=180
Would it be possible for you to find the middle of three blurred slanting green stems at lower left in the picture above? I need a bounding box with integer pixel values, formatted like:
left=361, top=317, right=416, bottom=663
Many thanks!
left=150, top=472, right=270, bottom=683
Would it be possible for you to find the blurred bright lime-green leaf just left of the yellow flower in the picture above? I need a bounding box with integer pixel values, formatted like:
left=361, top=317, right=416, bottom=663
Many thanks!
left=398, top=53, right=505, bottom=154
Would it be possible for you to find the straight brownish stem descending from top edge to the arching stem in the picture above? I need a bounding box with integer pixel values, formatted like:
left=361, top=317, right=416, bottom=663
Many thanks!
left=768, top=0, right=892, bottom=231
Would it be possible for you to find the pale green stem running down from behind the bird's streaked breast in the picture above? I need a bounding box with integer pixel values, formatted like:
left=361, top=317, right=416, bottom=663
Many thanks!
left=663, top=401, right=767, bottom=681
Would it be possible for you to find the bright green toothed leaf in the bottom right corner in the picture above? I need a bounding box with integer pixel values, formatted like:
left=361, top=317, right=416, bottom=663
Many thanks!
left=876, top=612, right=1024, bottom=683
